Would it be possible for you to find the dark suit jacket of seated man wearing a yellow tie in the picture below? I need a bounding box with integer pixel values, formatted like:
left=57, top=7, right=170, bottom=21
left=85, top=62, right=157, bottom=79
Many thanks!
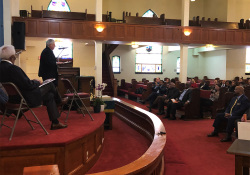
left=225, top=95, right=250, bottom=116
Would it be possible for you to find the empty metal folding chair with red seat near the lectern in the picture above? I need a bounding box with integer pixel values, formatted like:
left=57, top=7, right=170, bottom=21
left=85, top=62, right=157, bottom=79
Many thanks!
left=61, top=78, right=94, bottom=122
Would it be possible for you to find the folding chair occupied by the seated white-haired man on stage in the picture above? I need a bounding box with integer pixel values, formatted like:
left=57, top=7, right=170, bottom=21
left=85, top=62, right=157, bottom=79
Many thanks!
left=0, top=82, right=49, bottom=140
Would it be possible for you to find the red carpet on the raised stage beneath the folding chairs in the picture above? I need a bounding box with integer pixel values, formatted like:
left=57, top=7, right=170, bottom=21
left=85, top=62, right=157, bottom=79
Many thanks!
left=0, top=107, right=105, bottom=149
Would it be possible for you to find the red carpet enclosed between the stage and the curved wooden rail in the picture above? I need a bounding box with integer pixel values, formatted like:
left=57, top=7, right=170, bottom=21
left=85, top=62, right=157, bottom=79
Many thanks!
left=88, top=117, right=150, bottom=173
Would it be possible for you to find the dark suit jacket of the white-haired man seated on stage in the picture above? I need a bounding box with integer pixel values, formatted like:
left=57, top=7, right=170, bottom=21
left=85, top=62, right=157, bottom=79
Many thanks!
left=0, top=61, right=42, bottom=107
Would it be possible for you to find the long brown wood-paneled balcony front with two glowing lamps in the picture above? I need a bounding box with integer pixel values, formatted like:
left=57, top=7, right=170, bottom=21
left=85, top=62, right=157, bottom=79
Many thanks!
left=13, top=17, right=250, bottom=45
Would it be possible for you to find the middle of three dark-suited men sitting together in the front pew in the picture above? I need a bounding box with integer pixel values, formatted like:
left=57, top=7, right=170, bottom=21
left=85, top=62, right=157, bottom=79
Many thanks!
left=153, top=82, right=180, bottom=115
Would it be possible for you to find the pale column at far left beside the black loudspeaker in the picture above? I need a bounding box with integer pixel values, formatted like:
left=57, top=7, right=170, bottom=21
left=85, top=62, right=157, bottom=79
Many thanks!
left=3, top=0, right=12, bottom=45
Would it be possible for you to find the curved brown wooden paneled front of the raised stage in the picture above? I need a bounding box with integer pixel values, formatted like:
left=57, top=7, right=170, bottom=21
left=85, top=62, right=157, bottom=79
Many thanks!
left=0, top=125, right=104, bottom=175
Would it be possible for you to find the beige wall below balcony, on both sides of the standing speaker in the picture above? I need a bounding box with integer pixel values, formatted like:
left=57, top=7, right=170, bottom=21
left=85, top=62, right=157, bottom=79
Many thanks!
left=20, top=38, right=95, bottom=79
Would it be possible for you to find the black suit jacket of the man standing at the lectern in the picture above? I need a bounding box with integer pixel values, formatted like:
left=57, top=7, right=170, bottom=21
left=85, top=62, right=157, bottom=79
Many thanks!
left=38, top=47, right=58, bottom=85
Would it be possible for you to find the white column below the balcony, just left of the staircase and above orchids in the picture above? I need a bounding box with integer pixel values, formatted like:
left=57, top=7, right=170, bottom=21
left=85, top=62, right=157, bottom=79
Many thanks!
left=95, top=41, right=102, bottom=95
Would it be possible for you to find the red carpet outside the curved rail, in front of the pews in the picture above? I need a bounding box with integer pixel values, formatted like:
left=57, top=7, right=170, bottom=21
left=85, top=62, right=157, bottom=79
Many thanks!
left=115, top=98, right=235, bottom=175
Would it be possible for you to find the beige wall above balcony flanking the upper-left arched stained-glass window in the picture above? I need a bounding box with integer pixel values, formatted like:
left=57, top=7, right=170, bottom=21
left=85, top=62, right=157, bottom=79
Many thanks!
left=19, top=0, right=95, bottom=14
